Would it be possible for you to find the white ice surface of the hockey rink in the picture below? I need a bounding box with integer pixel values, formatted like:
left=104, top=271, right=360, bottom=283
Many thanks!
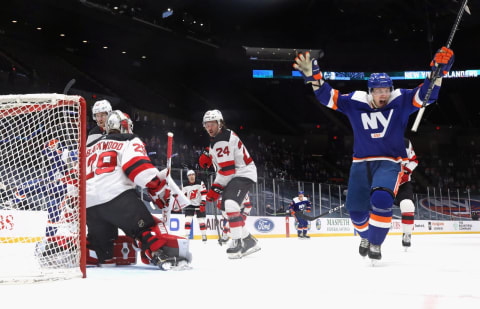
left=0, top=234, right=480, bottom=309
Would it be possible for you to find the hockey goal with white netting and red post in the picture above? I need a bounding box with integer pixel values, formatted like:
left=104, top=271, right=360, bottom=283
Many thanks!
left=0, top=94, right=86, bottom=283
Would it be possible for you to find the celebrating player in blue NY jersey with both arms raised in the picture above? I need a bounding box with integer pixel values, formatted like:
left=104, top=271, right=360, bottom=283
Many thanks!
left=293, top=47, right=454, bottom=263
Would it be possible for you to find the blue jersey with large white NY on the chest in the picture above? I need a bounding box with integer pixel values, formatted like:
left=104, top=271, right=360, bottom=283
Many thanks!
left=315, top=79, right=440, bottom=162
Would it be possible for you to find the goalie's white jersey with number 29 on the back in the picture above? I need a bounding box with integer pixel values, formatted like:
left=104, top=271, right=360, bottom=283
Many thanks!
left=86, top=134, right=166, bottom=207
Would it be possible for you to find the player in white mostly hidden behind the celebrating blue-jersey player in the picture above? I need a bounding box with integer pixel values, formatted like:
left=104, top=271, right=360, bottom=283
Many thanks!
left=395, top=138, right=418, bottom=250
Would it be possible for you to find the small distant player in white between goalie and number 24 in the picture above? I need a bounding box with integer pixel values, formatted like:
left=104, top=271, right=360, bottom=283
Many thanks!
left=182, top=170, right=207, bottom=242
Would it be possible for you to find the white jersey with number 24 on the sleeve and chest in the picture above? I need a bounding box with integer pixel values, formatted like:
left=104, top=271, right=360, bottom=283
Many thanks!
left=210, top=129, right=257, bottom=187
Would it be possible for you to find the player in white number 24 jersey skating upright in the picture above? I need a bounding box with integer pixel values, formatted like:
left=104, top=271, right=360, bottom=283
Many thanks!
left=203, top=109, right=260, bottom=259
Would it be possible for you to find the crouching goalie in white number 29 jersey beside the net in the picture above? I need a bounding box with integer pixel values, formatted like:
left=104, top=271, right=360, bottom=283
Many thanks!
left=86, top=110, right=191, bottom=269
